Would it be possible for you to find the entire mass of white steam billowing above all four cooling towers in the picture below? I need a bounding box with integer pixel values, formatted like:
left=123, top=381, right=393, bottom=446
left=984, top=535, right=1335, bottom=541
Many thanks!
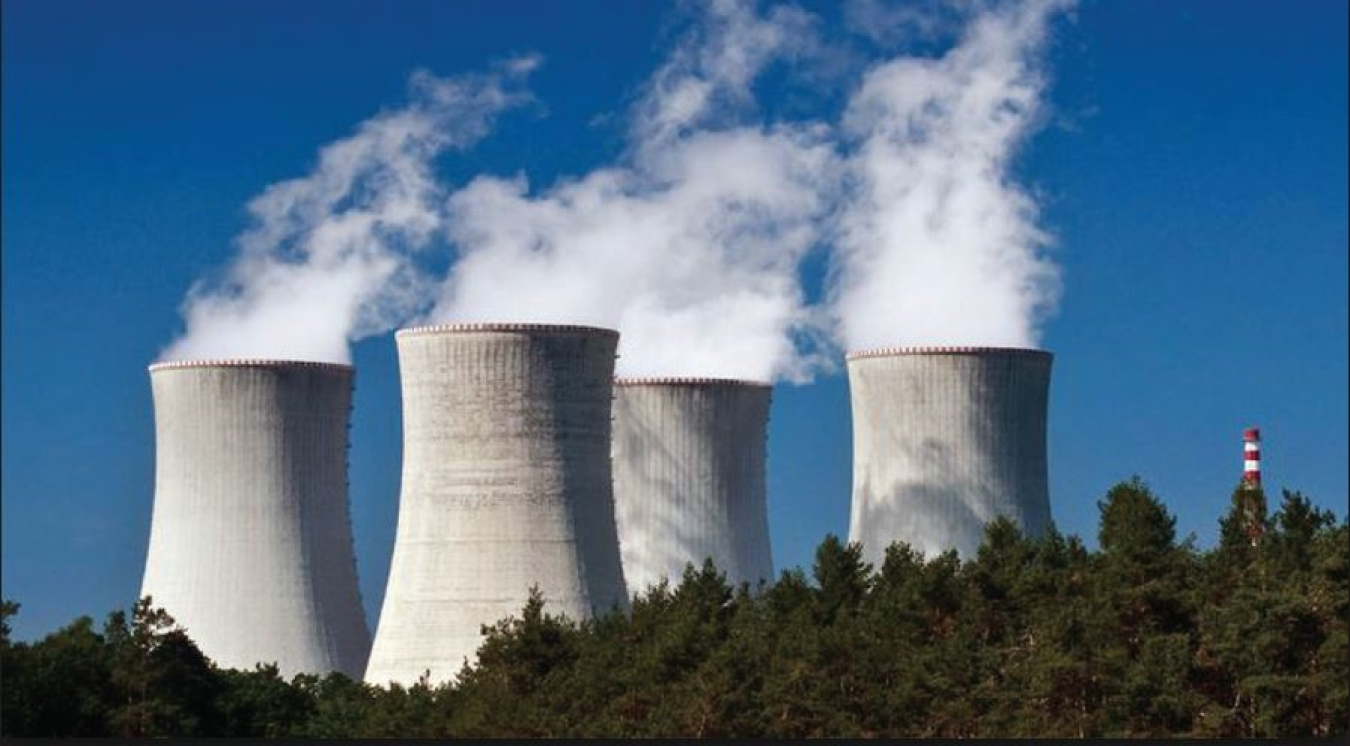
left=163, top=0, right=1065, bottom=372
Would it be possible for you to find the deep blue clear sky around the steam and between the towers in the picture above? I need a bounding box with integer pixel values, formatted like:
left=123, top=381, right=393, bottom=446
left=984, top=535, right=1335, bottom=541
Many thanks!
left=0, top=0, right=1350, bottom=637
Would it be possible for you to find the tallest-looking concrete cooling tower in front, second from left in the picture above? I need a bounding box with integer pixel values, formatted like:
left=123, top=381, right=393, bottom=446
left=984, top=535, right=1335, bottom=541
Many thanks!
left=366, top=324, right=628, bottom=684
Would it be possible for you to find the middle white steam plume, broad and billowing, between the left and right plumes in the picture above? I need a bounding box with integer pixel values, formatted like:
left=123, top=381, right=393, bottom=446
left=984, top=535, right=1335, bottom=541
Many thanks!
left=431, top=1, right=837, bottom=380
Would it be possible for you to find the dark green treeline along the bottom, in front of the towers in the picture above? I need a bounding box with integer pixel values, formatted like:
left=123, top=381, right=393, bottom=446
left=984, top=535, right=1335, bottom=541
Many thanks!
left=0, top=479, right=1350, bottom=738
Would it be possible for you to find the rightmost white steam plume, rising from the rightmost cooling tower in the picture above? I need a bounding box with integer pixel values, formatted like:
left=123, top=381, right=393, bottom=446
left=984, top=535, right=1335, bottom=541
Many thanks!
left=829, top=1, right=1065, bottom=349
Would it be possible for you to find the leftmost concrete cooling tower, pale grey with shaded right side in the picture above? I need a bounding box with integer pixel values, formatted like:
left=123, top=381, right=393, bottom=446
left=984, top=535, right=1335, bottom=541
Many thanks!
left=142, top=360, right=370, bottom=677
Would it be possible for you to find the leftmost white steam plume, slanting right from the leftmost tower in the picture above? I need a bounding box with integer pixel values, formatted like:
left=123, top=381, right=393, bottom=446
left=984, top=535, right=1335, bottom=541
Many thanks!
left=161, top=57, right=537, bottom=363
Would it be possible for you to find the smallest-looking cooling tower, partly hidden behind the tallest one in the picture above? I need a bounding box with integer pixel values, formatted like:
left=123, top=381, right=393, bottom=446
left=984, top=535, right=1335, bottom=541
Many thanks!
left=613, top=378, right=774, bottom=594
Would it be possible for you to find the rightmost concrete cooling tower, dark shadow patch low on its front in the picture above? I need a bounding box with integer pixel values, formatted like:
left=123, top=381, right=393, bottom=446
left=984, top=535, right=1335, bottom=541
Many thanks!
left=848, top=347, right=1052, bottom=568
